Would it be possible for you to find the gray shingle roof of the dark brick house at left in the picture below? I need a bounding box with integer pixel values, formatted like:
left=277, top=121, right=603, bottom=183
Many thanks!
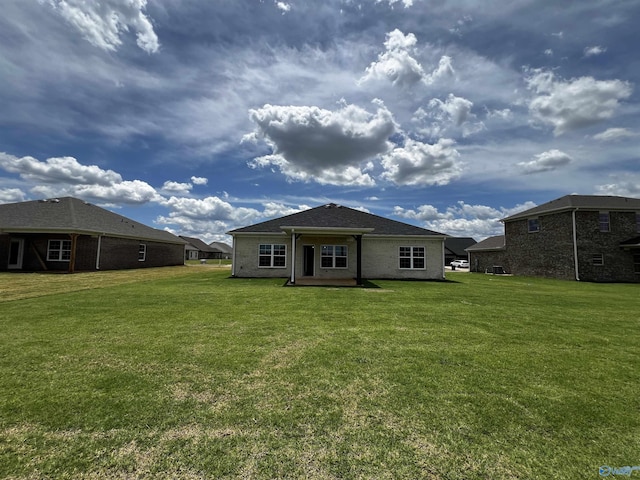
left=0, top=197, right=185, bottom=244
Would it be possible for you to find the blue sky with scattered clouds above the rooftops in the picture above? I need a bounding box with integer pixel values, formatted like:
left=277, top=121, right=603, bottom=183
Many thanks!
left=0, top=0, right=640, bottom=242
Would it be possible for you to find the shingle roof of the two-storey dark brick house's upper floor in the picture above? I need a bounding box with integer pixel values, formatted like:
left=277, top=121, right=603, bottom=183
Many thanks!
left=502, top=195, right=640, bottom=222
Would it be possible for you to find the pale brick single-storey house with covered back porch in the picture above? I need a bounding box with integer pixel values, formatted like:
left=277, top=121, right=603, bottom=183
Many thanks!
left=228, top=203, right=446, bottom=284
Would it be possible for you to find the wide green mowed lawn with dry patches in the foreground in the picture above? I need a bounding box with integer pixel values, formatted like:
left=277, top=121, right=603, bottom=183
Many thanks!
left=0, top=266, right=640, bottom=479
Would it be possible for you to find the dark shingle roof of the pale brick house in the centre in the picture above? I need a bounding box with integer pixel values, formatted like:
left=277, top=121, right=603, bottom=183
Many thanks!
left=228, top=203, right=446, bottom=237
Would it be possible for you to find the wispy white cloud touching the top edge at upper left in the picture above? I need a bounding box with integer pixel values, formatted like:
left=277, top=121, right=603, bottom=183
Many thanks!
left=48, top=0, right=160, bottom=53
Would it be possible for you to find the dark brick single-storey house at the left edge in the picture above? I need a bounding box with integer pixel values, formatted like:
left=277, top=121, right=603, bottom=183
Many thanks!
left=0, top=197, right=185, bottom=273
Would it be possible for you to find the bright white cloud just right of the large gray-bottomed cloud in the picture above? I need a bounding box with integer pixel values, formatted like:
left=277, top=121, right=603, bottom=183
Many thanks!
left=382, top=138, right=462, bottom=185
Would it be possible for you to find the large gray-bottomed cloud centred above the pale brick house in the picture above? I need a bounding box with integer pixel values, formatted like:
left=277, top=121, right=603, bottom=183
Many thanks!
left=244, top=102, right=396, bottom=185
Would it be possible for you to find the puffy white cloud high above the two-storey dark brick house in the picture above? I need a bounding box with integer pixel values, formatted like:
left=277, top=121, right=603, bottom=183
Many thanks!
left=527, top=70, right=632, bottom=135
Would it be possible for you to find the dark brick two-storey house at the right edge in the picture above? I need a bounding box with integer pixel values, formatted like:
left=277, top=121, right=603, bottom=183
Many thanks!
left=467, top=195, right=640, bottom=282
